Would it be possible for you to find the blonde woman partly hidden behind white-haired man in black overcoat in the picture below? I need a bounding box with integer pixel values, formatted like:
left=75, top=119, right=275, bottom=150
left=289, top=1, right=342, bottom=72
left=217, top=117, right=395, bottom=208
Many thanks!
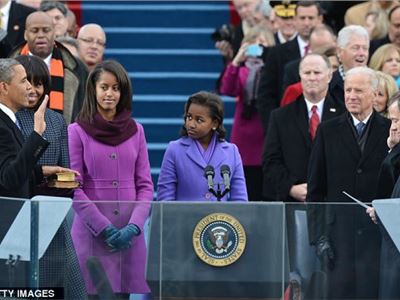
left=373, top=71, right=399, bottom=117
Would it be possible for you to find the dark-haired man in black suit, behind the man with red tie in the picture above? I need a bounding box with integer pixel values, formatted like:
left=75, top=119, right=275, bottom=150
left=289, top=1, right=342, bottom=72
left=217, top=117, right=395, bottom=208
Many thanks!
left=257, top=1, right=322, bottom=132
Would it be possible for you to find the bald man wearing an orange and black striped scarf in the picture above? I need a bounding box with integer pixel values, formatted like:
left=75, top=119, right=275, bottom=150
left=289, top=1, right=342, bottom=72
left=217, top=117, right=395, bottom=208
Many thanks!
left=10, top=11, right=88, bottom=124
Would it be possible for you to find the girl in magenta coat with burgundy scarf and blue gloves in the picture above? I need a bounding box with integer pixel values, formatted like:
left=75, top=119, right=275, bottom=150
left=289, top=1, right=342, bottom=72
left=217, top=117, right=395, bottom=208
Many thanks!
left=68, top=61, right=153, bottom=299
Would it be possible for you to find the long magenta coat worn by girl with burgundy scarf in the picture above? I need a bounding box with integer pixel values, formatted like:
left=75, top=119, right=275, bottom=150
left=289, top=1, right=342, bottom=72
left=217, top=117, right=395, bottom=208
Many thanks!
left=68, top=123, right=153, bottom=294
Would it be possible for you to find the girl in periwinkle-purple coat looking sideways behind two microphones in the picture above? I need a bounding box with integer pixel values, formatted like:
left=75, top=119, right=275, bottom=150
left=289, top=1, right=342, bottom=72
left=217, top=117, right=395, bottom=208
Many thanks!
left=157, top=92, right=247, bottom=201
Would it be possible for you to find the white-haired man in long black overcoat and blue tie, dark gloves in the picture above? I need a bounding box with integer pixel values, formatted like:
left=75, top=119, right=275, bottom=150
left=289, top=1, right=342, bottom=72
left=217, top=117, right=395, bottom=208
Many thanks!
left=307, top=67, right=390, bottom=299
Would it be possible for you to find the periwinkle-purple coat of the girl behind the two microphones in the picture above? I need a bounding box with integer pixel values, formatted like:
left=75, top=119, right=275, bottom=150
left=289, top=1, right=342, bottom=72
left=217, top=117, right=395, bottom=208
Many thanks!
left=157, top=137, right=247, bottom=201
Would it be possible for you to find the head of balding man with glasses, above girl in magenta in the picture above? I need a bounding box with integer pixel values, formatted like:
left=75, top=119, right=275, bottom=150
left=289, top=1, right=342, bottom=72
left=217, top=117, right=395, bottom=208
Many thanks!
left=78, top=24, right=106, bottom=70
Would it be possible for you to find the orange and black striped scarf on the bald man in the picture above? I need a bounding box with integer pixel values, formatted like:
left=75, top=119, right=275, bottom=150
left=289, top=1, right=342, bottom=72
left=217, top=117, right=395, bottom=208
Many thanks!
left=21, top=44, right=64, bottom=114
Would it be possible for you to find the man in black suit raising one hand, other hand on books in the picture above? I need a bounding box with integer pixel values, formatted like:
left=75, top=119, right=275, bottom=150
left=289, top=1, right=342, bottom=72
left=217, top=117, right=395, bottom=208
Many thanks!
left=0, top=59, right=76, bottom=286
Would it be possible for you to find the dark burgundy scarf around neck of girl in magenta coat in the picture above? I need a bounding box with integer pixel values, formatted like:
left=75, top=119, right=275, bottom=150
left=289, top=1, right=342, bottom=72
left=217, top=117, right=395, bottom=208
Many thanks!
left=77, top=109, right=137, bottom=146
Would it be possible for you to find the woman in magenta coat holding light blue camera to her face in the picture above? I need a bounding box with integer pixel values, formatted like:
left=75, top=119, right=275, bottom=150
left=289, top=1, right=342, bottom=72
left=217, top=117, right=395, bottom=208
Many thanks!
left=219, top=26, right=275, bottom=201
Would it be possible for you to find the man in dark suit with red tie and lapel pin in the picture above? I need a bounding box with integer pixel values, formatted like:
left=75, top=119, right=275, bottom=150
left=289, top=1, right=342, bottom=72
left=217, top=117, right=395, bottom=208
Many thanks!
left=263, top=54, right=344, bottom=296
